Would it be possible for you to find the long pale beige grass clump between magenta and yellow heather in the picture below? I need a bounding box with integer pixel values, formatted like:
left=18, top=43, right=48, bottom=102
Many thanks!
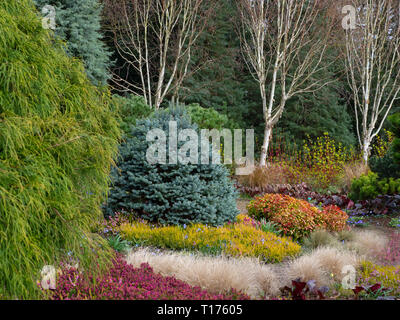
left=126, top=248, right=279, bottom=298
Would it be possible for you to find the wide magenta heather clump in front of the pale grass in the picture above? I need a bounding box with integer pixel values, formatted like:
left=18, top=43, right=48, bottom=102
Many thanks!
left=52, top=255, right=250, bottom=300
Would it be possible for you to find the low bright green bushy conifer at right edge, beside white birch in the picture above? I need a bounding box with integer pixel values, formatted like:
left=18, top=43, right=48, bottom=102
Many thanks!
left=349, top=172, right=400, bottom=201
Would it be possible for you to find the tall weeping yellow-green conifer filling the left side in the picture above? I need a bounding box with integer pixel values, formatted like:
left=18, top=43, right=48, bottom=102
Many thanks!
left=0, top=0, right=120, bottom=299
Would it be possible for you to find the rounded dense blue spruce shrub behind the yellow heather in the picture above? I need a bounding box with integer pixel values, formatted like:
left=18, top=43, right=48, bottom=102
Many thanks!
left=105, top=107, right=239, bottom=225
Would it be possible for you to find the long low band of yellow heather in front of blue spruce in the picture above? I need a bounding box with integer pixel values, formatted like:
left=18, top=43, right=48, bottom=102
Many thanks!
left=119, top=215, right=301, bottom=262
